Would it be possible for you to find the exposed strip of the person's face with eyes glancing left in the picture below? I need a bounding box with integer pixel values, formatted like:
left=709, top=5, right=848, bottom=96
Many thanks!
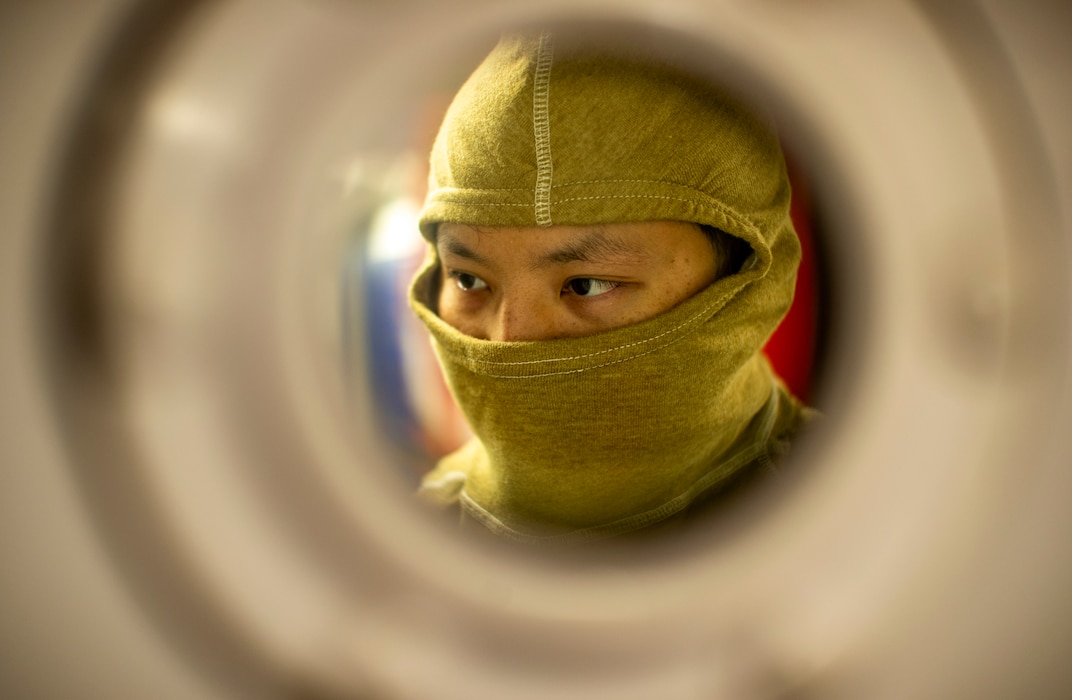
left=436, top=216, right=717, bottom=341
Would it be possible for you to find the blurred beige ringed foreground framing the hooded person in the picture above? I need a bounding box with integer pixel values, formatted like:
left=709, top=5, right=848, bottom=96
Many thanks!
left=0, top=0, right=1072, bottom=699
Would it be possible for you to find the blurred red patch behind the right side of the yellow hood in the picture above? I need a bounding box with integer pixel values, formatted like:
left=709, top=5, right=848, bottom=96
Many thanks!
left=763, top=155, right=819, bottom=403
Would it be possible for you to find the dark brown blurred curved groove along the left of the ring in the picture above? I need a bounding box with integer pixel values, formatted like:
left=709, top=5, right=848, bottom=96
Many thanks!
left=35, top=0, right=291, bottom=696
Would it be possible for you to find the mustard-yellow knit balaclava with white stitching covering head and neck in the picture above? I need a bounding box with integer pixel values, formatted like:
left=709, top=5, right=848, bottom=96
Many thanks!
left=411, top=33, right=800, bottom=542
